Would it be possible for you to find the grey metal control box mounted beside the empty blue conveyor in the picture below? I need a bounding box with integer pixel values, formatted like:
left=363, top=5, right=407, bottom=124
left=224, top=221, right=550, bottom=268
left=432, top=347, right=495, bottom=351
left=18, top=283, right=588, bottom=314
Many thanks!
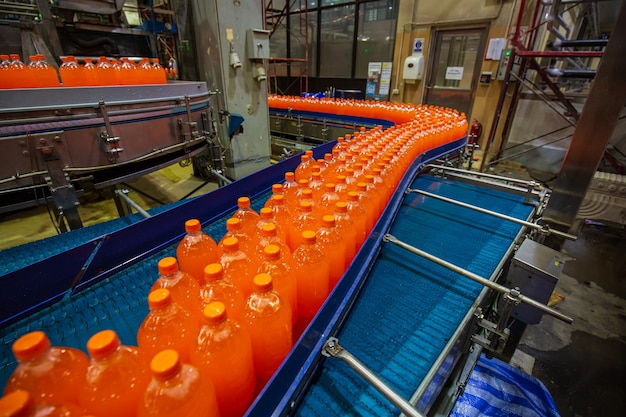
left=505, top=239, right=566, bottom=324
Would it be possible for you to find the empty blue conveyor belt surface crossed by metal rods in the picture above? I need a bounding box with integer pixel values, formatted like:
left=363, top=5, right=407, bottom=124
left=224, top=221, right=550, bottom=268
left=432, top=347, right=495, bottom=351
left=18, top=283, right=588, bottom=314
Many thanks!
left=298, top=176, right=532, bottom=416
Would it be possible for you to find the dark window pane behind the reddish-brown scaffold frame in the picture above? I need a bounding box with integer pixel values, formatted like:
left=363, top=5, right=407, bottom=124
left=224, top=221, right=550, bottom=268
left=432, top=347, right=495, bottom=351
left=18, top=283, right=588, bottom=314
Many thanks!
left=289, top=12, right=317, bottom=77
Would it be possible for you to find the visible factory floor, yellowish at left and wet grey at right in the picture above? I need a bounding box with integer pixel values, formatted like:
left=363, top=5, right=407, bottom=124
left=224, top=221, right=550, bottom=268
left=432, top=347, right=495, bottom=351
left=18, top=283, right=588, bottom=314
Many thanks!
left=0, top=160, right=626, bottom=417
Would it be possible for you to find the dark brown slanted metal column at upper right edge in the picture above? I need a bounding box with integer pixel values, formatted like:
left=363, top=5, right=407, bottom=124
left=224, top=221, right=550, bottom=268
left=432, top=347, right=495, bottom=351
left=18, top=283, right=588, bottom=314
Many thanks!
left=543, top=2, right=626, bottom=234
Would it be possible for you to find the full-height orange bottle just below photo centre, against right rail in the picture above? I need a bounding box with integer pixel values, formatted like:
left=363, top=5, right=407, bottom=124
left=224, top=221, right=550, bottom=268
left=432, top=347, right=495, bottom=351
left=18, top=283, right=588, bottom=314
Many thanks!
left=292, top=230, right=330, bottom=321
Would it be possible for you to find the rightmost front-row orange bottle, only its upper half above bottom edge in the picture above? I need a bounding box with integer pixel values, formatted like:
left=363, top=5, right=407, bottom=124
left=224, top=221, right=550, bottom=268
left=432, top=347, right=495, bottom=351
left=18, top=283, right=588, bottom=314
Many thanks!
left=137, top=349, right=220, bottom=417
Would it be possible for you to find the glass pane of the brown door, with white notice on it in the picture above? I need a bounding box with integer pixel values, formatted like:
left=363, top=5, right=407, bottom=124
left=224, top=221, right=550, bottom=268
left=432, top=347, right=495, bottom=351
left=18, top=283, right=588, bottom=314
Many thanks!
left=435, top=34, right=480, bottom=90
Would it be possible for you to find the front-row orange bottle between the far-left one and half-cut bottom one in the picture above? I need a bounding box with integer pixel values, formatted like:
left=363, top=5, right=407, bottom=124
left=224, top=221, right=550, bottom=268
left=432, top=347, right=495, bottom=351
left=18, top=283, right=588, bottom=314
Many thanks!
left=81, top=330, right=149, bottom=417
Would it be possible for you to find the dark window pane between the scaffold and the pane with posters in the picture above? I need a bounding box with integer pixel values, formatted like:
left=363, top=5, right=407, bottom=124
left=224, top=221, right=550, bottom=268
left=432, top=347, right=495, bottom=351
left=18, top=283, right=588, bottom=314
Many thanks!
left=320, top=5, right=354, bottom=78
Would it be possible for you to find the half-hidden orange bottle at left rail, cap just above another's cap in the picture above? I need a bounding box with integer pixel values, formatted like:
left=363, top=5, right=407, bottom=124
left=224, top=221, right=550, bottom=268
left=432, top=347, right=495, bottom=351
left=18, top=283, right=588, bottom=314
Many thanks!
left=150, top=257, right=200, bottom=312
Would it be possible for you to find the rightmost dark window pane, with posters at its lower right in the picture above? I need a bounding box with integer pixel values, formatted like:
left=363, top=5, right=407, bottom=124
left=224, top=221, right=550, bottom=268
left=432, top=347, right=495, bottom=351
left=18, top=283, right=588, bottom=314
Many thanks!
left=354, top=0, right=396, bottom=78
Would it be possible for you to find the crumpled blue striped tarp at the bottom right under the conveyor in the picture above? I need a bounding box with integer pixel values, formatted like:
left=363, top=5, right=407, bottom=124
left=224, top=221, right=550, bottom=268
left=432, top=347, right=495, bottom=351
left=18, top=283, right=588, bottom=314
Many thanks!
left=450, top=355, right=559, bottom=417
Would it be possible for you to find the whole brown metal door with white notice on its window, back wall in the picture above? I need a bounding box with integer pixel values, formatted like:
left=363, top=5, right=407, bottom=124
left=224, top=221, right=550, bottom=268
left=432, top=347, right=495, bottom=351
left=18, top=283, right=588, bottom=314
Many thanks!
left=424, top=26, right=487, bottom=117
